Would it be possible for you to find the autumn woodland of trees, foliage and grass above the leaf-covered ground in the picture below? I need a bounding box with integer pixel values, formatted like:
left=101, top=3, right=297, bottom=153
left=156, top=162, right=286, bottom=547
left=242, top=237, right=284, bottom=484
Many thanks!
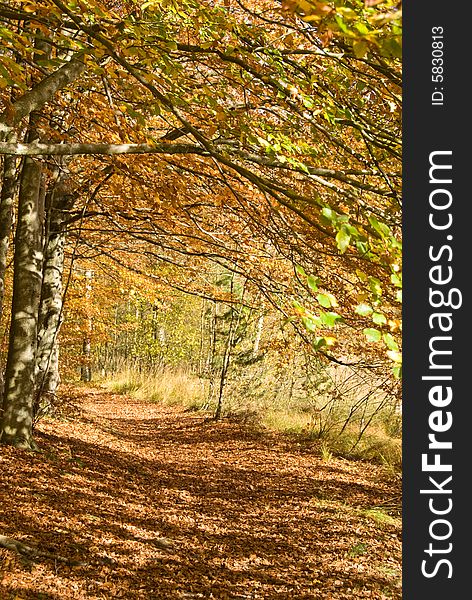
left=0, top=0, right=401, bottom=597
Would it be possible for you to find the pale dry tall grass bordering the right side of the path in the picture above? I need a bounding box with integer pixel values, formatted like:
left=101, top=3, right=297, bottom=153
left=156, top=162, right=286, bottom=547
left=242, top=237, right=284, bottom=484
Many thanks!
left=105, top=369, right=402, bottom=470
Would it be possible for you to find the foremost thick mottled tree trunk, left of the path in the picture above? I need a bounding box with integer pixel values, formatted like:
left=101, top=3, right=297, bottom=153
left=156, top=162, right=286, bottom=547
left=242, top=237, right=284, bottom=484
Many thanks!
left=0, top=158, right=44, bottom=449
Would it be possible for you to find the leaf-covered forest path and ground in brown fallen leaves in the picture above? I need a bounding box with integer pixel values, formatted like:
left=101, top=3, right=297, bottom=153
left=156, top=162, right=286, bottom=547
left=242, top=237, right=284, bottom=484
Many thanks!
left=0, top=388, right=401, bottom=600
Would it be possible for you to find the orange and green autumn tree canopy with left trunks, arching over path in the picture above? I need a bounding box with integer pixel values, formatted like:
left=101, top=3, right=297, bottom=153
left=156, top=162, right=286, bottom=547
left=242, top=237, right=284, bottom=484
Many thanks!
left=0, top=0, right=401, bottom=445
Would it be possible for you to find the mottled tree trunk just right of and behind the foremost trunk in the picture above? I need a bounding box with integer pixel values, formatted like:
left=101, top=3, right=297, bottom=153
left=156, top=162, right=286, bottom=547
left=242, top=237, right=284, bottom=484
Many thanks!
left=35, top=190, right=74, bottom=413
